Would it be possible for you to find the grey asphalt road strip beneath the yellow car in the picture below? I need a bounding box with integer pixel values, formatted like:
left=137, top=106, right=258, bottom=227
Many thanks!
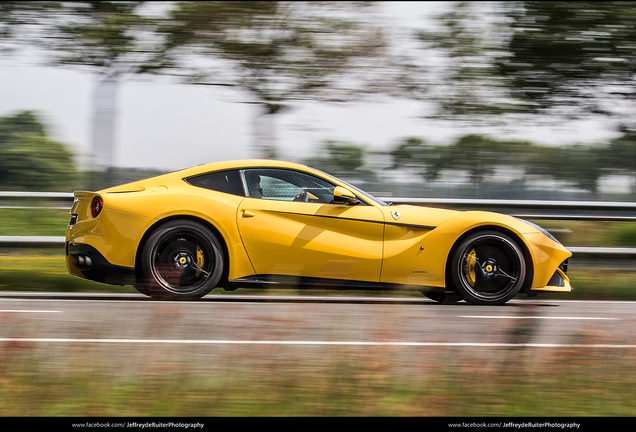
left=0, top=292, right=636, bottom=350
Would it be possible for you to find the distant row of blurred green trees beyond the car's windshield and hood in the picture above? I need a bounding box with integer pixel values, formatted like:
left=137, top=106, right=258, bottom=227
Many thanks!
left=312, top=134, right=636, bottom=193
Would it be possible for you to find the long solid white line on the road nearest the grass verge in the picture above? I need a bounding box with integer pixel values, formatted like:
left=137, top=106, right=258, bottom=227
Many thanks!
left=0, top=338, right=636, bottom=348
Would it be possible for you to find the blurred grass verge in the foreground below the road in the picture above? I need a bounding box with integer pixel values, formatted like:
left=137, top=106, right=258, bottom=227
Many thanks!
left=0, top=342, right=636, bottom=417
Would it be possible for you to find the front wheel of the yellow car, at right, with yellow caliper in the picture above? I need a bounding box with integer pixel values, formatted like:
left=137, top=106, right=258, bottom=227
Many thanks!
left=450, top=231, right=528, bottom=305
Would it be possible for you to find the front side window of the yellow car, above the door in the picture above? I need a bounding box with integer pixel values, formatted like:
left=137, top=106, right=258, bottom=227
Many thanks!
left=243, top=168, right=335, bottom=204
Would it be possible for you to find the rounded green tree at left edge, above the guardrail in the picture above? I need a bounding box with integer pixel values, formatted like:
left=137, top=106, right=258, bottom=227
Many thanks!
left=0, top=111, right=77, bottom=191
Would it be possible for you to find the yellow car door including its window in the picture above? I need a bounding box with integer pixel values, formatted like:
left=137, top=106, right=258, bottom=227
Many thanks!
left=237, top=168, right=384, bottom=282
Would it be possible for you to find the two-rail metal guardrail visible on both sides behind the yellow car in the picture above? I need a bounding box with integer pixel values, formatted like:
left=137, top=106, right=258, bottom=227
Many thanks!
left=0, top=192, right=636, bottom=259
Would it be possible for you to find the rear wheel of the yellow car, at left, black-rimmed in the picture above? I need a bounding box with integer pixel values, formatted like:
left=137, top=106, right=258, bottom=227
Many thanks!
left=139, top=220, right=224, bottom=300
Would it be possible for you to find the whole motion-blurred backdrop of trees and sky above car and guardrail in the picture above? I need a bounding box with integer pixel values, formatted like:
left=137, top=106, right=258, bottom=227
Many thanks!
left=0, top=1, right=636, bottom=197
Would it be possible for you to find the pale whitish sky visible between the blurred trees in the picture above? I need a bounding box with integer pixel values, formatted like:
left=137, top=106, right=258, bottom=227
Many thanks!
left=0, top=2, right=615, bottom=174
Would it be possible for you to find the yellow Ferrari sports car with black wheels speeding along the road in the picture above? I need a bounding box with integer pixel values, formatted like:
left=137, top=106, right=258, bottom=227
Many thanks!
left=66, top=160, right=572, bottom=305
